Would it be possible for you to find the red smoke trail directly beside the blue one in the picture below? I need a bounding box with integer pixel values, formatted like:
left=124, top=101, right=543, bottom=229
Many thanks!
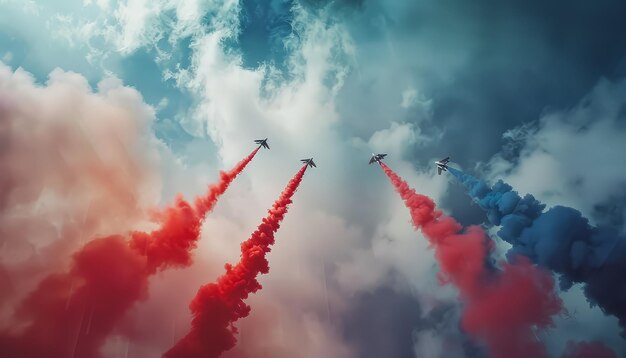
left=381, top=163, right=562, bottom=358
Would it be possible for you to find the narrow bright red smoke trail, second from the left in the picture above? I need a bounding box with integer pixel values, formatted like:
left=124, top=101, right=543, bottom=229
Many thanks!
left=163, top=165, right=307, bottom=358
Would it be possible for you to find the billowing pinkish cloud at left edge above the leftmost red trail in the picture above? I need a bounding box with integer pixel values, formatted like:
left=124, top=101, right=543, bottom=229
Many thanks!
left=0, top=63, right=164, bottom=325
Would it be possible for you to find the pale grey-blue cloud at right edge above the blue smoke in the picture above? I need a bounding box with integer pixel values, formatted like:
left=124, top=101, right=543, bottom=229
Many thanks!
left=489, top=80, right=626, bottom=228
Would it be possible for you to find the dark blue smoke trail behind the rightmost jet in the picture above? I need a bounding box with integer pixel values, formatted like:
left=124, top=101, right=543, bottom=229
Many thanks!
left=448, top=168, right=626, bottom=338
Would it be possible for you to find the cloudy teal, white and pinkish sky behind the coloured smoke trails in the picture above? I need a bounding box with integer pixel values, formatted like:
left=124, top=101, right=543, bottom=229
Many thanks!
left=0, top=0, right=626, bottom=358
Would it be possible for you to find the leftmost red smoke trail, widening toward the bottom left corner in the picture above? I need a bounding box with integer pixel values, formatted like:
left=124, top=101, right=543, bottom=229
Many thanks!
left=0, top=148, right=258, bottom=358
